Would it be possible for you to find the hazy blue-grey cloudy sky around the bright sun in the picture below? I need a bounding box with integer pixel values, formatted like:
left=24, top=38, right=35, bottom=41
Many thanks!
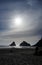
left=0, top=0, right=42, bottom=45
